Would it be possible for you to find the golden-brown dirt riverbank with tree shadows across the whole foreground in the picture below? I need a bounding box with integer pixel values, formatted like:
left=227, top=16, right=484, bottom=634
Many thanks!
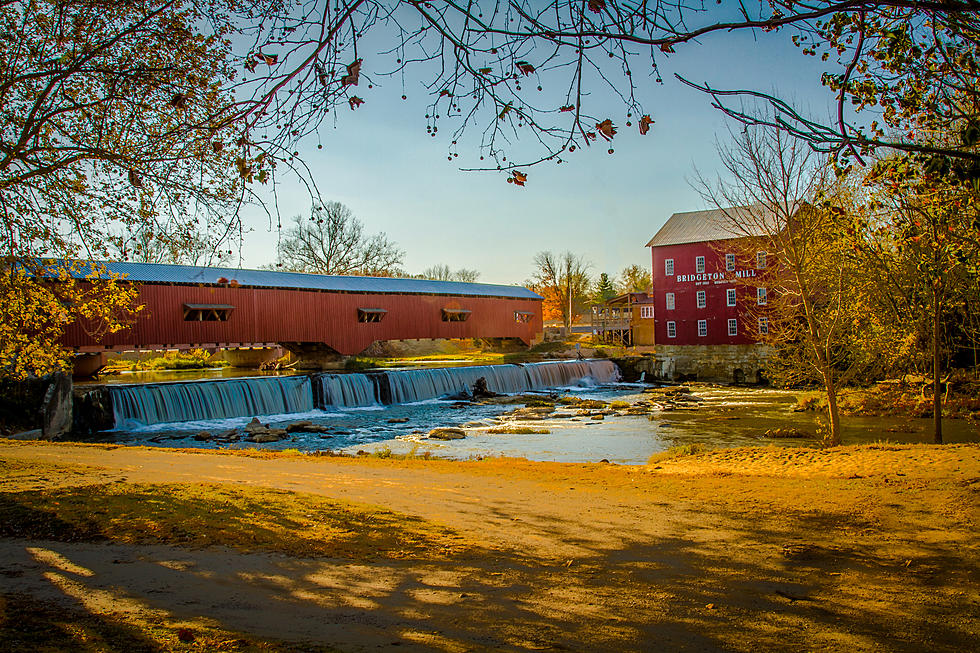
left=0, top=441, right=980, bottom=651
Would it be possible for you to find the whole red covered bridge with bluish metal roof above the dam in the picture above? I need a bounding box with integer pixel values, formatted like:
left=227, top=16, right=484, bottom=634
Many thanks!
left=64, top=262, right=543, bottom=364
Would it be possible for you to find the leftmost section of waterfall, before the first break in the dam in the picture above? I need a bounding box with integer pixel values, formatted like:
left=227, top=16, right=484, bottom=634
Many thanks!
left=109, top=376, right=313, bottom=427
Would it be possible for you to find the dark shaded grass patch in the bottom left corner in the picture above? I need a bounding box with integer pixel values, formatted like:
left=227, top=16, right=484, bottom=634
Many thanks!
left=0, top=594, right=336, bottom=653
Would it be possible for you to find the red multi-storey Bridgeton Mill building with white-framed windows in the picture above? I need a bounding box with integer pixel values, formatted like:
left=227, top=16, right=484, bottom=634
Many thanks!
left=647, top=209, right=768, bottom=382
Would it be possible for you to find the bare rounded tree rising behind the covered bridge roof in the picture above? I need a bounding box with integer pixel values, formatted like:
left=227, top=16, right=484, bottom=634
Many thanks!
left=277, top=202, right=405, bottom=277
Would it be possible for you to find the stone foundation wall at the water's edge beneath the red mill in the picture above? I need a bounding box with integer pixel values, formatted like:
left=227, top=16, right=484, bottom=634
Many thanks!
left=616, top=345, right=769, bottom=383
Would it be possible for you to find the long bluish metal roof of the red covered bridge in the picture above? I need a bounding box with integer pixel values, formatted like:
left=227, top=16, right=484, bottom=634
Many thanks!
left=57, top=261, right=542, bottom=299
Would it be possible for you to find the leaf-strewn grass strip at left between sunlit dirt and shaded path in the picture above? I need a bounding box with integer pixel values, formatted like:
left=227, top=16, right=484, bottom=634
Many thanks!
left=0, top=483, right=469, bottom=559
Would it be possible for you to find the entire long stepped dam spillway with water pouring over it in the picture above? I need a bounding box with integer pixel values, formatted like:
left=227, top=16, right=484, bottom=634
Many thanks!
left=109, top=360, right=620, bottom=428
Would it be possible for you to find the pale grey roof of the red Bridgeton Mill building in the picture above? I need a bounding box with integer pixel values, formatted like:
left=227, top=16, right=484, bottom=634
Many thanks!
left=647, top=204, right=772, bottom=247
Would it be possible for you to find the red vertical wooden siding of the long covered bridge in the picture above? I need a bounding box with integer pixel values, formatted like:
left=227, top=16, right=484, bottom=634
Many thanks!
left=63, top=284, right=543, bottom=355
